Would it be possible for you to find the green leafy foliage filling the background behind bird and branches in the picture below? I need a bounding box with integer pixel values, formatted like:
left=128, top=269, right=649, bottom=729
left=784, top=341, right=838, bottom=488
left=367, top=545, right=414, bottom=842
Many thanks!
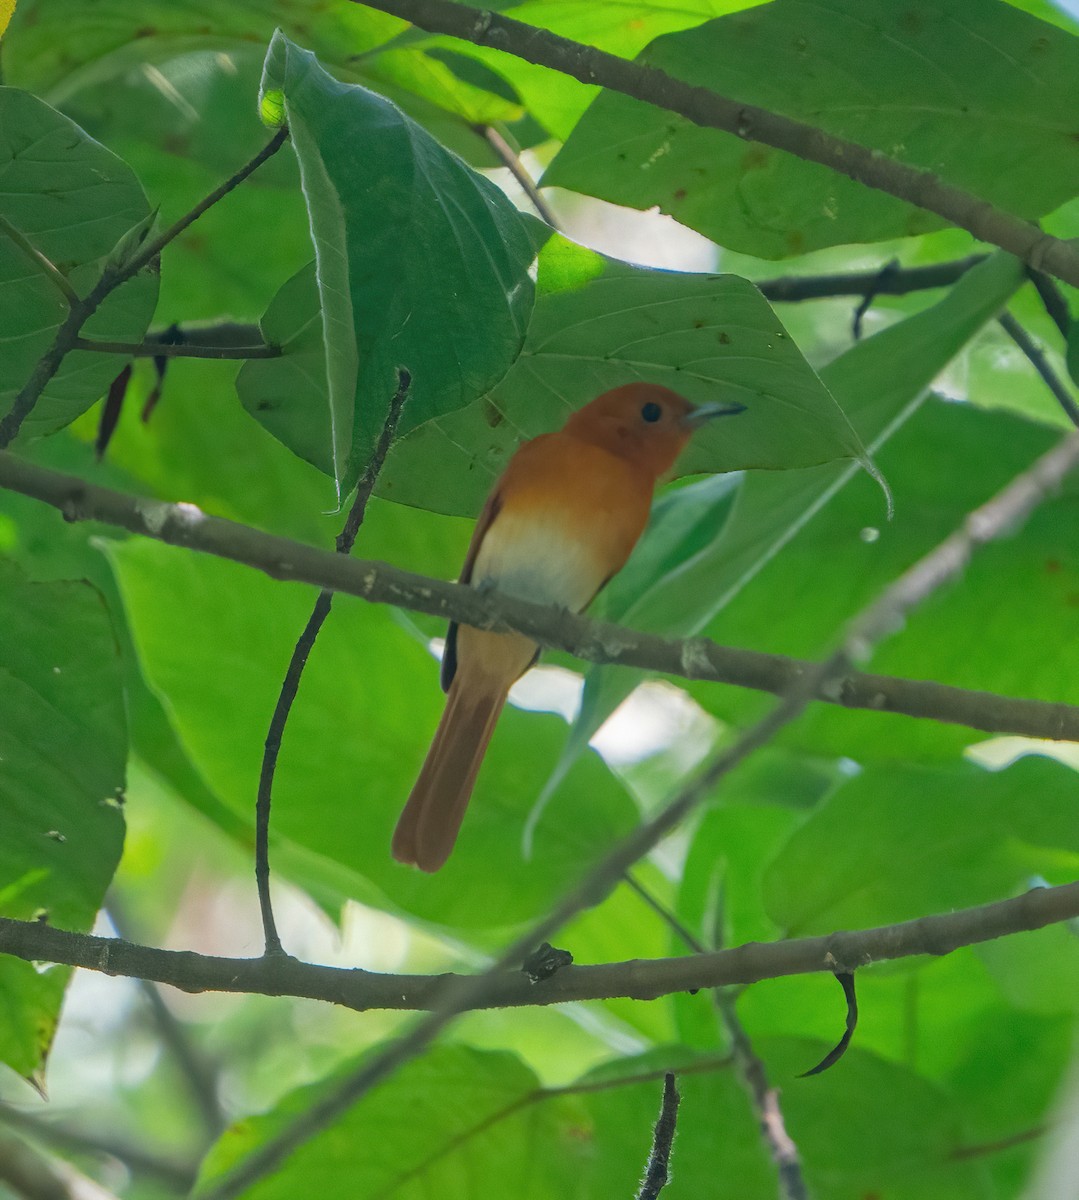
left=0, top=0, right=1079, bottom=1200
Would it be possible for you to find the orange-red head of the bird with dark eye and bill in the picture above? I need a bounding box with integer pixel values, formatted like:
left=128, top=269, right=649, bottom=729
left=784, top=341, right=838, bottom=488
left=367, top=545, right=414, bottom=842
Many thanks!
left=565, top=383, right=745, bottom=479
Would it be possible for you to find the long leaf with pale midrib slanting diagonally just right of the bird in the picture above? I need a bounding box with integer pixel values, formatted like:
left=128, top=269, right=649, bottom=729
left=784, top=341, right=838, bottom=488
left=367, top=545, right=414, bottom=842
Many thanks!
left=552, top=254, right=1023, bottom=792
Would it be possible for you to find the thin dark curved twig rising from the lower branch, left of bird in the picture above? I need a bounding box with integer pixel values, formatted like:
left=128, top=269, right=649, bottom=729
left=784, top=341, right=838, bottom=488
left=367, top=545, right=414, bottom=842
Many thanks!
left=254, top=367, right=412, bottom=954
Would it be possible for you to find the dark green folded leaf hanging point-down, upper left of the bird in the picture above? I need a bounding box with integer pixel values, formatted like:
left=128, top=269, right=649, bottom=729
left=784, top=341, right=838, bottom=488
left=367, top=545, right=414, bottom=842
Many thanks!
left=250, top=32, right=533, bottom=496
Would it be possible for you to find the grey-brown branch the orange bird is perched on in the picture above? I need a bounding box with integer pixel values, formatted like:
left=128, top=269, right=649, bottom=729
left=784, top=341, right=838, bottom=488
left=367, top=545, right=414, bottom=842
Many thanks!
left=0, top=452, right=1079, bottom=742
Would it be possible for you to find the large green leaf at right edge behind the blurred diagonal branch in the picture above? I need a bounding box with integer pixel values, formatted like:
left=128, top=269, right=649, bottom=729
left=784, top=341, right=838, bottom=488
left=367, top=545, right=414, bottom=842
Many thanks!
left=693, top=402, right=1079, bottom=762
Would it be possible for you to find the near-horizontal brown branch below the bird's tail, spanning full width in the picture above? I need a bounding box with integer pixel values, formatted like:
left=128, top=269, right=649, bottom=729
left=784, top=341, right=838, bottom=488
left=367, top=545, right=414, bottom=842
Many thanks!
left=0, top=883, right=1079, bottom=1012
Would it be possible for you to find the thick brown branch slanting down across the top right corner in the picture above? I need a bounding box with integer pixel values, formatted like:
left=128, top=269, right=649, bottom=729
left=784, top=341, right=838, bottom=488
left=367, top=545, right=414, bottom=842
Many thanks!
left=354, top=0, right=1079, bottom=286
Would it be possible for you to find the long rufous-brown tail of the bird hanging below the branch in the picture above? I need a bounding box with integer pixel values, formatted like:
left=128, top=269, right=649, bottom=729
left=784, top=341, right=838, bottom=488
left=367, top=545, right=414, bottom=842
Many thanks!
left=394, top=674, right=509, bottom=871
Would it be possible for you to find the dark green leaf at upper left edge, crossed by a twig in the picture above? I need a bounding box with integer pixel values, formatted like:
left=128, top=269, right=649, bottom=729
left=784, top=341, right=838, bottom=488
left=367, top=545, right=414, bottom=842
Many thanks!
left=0, top=88, right=157, bottom=436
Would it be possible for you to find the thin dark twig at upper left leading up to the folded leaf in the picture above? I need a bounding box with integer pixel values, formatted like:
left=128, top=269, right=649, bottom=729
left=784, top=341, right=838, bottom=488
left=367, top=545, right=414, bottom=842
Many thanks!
left=0, top=128, right=288, bottom=450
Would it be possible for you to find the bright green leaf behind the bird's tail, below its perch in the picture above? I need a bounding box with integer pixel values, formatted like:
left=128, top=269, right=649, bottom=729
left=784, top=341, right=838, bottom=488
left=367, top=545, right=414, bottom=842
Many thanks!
left=109, top=535, right=636, bottom=929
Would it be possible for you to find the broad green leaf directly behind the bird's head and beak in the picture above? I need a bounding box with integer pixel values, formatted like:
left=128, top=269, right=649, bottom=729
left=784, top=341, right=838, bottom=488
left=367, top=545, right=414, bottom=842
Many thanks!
left=382, top=235, right=864, bottom=514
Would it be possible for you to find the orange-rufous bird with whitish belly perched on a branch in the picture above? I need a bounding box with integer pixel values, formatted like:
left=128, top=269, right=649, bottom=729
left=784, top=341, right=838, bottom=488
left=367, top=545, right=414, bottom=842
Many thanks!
left=392, top=383, right=745, bottom=872
